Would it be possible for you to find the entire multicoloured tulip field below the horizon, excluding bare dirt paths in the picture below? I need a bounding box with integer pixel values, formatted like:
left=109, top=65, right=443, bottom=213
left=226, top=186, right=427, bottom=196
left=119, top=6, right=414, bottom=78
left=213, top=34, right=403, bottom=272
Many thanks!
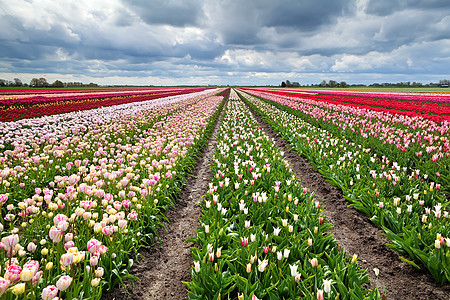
left=0, top=88, right=450, bottom=300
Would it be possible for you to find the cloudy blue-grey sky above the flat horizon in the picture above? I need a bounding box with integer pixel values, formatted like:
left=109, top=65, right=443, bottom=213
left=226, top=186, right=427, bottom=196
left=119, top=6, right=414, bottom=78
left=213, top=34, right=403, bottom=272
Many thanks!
left=0, top=0, right=450, bottom=85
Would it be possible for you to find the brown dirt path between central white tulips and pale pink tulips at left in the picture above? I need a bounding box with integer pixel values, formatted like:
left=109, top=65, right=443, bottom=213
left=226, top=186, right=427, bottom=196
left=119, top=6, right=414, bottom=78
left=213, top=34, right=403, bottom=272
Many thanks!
left=102, top=99, right=225, bottom=300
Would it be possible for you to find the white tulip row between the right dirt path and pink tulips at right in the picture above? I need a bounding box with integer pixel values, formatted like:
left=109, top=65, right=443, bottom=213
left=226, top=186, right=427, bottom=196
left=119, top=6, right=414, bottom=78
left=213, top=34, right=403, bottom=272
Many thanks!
left=241, top=89, right=450, bottom=283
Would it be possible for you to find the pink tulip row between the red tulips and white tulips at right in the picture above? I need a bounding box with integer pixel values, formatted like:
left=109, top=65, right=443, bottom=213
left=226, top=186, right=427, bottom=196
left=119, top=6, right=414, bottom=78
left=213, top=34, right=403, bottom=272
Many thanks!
left=243, top=91, right=450, bottom=192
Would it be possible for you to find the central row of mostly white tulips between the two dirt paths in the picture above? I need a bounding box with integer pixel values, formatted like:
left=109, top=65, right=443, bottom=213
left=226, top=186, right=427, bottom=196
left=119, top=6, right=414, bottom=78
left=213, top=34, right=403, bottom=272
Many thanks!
left=187, top=90, right=380, bottom=300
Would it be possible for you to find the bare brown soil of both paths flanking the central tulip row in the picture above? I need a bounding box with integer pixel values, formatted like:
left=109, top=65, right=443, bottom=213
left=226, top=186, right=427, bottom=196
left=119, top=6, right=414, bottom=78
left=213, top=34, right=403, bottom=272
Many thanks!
left=102, top=96, right=450, bottom=300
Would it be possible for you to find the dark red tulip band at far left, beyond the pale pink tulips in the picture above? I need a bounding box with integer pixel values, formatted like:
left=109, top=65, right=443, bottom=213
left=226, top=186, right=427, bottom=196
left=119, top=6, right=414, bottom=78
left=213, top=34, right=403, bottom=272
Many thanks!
left=0, top=88, right=204, bottom=122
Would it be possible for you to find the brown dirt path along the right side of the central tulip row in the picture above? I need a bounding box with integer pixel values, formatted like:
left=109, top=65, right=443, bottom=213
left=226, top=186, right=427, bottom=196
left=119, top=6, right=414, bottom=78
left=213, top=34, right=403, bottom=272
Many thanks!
left=246, top=101, right=450, bottom=300
